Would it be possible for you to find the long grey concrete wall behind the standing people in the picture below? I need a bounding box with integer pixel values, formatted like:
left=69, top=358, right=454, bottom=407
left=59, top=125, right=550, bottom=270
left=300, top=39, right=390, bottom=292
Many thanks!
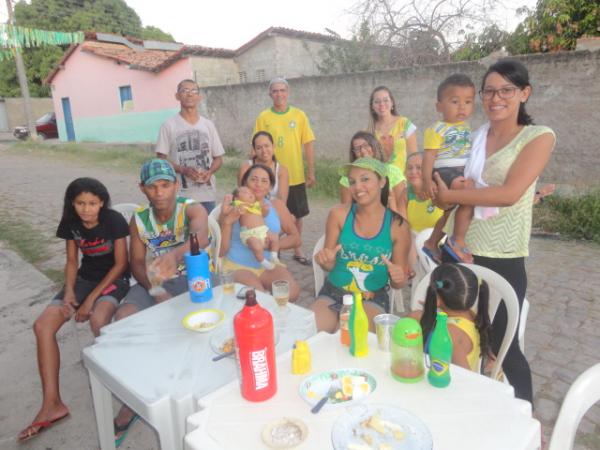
left=201, top=51, right=600, bottom=186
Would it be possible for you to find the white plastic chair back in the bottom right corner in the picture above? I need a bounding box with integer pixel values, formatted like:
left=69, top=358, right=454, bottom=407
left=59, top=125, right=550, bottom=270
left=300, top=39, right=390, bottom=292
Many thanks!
left=548, top=364, right=600, bottom=450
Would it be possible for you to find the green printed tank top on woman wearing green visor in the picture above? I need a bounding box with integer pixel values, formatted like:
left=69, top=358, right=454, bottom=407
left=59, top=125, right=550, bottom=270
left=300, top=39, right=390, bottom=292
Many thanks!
left=328, top=204, right=393, bottom=292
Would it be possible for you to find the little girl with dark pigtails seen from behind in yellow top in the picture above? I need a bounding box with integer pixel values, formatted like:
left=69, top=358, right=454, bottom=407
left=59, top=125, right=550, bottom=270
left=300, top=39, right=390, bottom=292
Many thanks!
left=419, top=263, right=491, bottom=372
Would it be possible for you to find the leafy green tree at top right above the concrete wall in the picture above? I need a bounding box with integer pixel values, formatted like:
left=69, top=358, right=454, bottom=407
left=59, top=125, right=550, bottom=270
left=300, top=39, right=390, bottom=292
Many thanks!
left=508, top=0, right=600, bottom=53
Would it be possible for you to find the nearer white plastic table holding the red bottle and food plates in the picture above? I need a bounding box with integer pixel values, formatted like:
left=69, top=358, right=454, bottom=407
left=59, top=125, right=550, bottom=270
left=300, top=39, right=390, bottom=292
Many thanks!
left=185, top=333, right=540, bottom=450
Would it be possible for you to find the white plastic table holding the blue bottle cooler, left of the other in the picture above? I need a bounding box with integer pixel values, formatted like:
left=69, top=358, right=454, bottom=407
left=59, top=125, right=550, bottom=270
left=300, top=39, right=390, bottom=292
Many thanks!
left=83, top=284, right=316, bottom=450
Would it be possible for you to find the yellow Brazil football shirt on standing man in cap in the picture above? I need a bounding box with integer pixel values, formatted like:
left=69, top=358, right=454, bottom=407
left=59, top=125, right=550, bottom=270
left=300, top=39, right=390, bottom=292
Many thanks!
left=254, top=106, right=315, bottom=186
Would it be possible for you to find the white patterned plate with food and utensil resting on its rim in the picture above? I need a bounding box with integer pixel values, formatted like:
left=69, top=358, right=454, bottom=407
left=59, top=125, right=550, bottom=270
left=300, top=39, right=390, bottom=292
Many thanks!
left=298, top=369, right=377, bottom=408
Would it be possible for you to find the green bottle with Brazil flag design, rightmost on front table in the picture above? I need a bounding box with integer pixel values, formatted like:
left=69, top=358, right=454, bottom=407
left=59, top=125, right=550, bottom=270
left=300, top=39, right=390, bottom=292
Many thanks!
left=427, top=310, right=452, bottom=387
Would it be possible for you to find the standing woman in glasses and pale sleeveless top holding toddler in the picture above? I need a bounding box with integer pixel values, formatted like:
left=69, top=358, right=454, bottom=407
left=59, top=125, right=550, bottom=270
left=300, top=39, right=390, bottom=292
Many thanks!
left=435, top=59, right=556, bottom=402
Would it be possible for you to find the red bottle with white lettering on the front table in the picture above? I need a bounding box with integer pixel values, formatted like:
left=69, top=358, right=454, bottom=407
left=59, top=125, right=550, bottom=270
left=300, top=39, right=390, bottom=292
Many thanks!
left=233, top=289, right=277, bottom=402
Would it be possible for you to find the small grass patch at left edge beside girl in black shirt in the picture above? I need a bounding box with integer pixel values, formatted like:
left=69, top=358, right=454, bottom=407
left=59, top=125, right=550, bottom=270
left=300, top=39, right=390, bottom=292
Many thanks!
left=0, top=214, right=50, bottom=265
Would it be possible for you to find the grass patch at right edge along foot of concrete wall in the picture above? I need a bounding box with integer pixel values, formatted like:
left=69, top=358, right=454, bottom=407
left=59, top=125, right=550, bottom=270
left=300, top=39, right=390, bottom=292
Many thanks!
left=533, top=188, right=600, bottom=243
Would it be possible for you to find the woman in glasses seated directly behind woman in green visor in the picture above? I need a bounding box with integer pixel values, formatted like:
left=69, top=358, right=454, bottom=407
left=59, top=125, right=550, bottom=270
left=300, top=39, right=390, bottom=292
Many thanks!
left=340, top=131, right=406, bottom=217
